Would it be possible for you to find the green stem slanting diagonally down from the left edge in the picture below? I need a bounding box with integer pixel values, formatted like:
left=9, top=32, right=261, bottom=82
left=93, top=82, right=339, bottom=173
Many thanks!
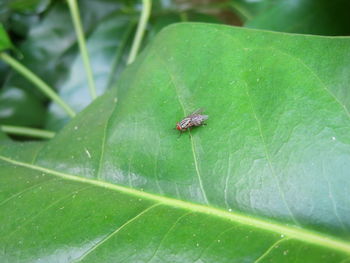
left=0, top=52, right=75, bottom=117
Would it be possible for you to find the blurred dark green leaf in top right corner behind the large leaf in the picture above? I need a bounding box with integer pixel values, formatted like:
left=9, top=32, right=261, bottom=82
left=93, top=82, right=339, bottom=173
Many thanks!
left=245, top=0, right=350, bottom=36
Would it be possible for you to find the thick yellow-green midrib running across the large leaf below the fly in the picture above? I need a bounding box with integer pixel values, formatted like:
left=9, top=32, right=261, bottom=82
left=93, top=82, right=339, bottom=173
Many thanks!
left=0, top=155, right=350, bottom=254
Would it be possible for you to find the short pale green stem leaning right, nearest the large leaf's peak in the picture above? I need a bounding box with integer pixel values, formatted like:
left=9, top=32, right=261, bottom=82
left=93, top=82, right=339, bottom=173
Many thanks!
left=127, top=0, right=152, bottom=64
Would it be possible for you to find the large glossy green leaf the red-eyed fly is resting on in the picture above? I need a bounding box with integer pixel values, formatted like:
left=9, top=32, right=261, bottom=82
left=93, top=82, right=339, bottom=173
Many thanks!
left=0, top=24, right=350, bottom=262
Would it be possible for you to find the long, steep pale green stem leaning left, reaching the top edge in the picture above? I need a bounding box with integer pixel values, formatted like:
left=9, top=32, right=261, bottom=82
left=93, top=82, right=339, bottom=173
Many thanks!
left=67, top=0, right=97, bottom=99
